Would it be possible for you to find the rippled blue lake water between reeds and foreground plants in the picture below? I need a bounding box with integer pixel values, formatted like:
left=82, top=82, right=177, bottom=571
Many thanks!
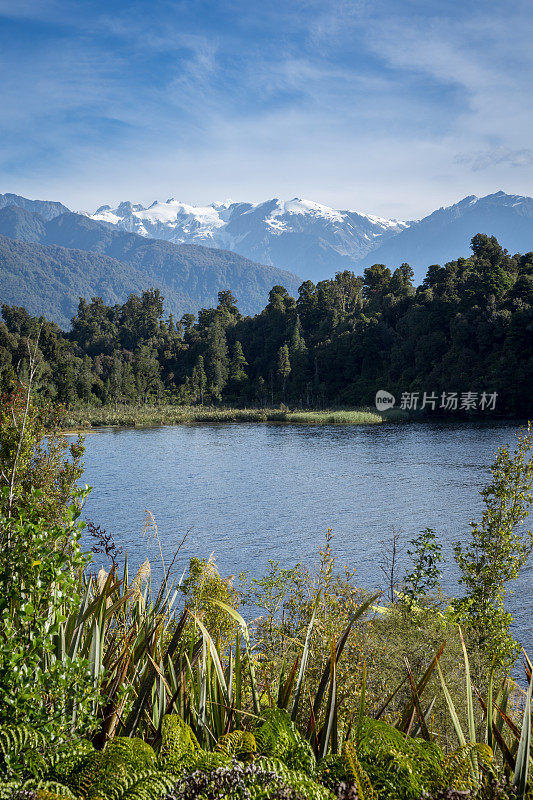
left=79, top=422, right=533, bottom=651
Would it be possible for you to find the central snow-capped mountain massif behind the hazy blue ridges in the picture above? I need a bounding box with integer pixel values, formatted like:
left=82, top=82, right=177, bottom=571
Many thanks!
left=90, top=197, right=409, bottom=281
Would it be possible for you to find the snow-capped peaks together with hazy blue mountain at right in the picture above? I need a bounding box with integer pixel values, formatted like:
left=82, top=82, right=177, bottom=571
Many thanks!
left=92, top=192, right=533, bottom=283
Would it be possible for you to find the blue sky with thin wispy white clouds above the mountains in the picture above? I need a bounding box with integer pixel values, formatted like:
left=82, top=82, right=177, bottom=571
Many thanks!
left=0, top=0, right=533, bottom=219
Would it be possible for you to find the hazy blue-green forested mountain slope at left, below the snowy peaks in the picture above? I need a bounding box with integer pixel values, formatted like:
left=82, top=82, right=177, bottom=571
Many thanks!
left=0, top=205, right=301, bottom=327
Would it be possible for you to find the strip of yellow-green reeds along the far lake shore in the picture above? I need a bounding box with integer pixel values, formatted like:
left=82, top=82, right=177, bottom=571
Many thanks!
left=63, top=405, right=408, bottom=430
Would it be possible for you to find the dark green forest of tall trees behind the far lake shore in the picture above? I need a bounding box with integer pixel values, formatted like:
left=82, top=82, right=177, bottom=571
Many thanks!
left=0, top=235, right=533, bottom=415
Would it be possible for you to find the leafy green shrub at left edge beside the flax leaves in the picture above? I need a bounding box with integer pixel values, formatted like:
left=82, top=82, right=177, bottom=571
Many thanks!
left=0, top=386, right=99, bottom=738
